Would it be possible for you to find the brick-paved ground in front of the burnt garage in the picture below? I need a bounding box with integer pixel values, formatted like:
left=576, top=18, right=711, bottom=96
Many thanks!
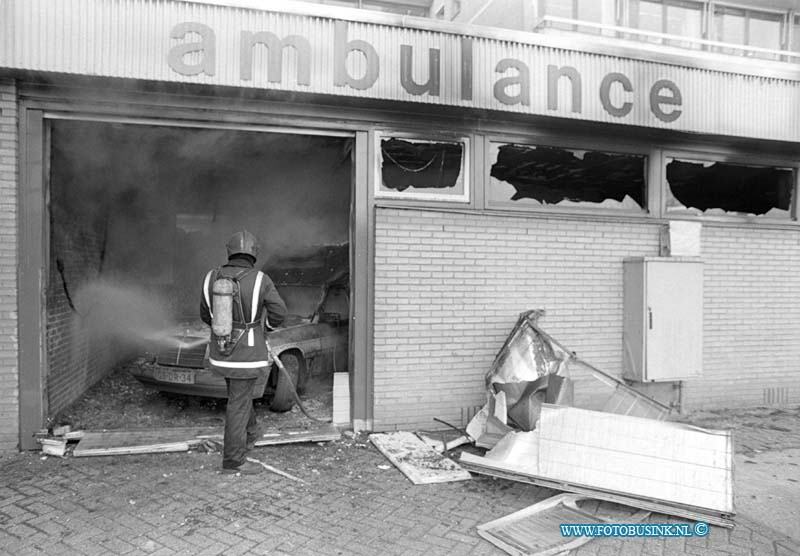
left=0, top=410, right=800, bottom=556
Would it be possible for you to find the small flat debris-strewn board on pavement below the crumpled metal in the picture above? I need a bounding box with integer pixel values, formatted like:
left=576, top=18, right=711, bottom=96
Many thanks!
left=369, top=431, right=470, bottom=485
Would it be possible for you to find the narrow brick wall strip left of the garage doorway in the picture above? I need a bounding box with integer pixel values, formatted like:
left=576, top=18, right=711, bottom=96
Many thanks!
left=0, top=79, right=19, bottom=452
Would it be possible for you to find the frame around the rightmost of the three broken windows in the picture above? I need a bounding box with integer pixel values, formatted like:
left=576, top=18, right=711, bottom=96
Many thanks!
left=659, top=148, right=800, bottom=227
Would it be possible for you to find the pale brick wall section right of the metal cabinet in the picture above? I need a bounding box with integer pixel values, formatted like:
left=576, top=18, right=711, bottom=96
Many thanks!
left=684, top=226, right=800, bottom=409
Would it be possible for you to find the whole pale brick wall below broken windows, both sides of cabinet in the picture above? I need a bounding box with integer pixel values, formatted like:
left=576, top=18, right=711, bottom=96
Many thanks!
left=374, top=208, right=800, bottom=430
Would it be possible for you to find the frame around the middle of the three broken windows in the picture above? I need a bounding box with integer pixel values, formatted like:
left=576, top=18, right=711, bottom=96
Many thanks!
left=482, top=134, right=659, bottom=219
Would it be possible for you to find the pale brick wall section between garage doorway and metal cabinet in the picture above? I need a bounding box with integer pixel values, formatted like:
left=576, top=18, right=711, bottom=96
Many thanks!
left=374, top=208, right=659, bottom=430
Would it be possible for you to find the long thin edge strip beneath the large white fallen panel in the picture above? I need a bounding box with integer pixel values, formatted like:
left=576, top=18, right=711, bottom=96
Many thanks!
left=458, top=452, right=734, bottom=528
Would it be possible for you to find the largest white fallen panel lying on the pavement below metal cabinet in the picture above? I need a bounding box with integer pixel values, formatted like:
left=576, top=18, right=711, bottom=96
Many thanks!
left=459, top=404, right=734, bottom=526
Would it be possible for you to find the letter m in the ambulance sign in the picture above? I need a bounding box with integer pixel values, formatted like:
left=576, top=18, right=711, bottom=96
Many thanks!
left=239, top=31, right=311, bottom=86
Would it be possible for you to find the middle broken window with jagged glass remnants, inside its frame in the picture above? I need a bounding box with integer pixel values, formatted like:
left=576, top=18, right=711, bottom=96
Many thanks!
left=489, top=143, right=646, bottom=211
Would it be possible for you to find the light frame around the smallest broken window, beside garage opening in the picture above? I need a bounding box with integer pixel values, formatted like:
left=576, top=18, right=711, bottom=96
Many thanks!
left=372, top=128, right=474, bottom=204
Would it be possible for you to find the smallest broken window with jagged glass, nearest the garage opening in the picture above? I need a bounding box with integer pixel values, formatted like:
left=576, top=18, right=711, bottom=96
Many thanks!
left=376, top=137, right=469, bottom=202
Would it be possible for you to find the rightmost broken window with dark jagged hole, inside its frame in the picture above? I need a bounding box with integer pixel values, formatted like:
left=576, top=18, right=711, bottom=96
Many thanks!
left=667, top=159, right=795, bottom=219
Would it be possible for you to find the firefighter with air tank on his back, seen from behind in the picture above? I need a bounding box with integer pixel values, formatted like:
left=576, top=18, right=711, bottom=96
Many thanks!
left=200, top=230, right=286, bottom=475
